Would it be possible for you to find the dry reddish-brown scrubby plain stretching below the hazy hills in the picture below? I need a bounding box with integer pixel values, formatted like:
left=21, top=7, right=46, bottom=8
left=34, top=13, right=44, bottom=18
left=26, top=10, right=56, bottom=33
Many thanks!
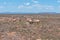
left=0, top=14, right=60, bottom=40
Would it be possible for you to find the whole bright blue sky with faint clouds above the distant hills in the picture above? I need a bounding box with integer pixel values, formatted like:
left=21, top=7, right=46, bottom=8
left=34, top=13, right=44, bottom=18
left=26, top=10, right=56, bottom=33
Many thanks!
left=0, top=0, right=60, bottom=13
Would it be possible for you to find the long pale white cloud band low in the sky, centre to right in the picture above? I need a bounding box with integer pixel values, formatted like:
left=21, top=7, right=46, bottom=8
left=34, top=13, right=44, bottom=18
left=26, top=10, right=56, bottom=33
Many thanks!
left=18, top=4, right=54, bottom=10
